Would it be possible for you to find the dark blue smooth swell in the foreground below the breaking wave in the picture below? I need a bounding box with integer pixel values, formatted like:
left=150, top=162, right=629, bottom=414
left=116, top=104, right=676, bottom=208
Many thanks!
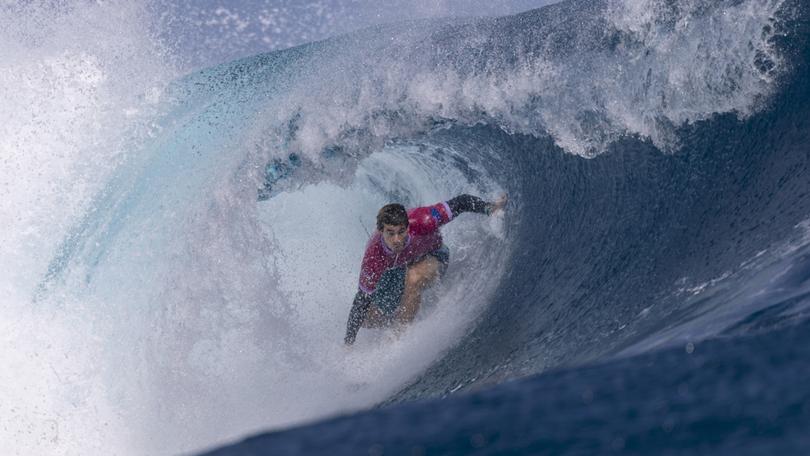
left=199, top=322, right=810, bottom=456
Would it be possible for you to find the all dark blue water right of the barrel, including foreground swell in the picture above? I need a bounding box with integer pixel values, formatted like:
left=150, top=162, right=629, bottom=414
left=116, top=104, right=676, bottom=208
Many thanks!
left=194, top=2, right=810, bottom=456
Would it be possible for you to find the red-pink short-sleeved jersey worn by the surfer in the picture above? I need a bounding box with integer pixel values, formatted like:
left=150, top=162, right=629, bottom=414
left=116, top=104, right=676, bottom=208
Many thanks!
left=360, top=202, right=453, bottom=293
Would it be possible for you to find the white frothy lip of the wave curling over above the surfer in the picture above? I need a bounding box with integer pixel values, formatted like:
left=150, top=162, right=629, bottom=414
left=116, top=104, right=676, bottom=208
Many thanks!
left=249, top=0, right=787, bottom=162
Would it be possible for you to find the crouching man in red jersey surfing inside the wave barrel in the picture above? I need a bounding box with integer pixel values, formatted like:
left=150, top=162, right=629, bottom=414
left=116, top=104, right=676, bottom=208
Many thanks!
left=344, top=195, right=506, bottom=345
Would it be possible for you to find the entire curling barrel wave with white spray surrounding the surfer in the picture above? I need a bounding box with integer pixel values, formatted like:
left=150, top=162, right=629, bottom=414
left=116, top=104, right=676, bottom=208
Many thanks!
left=0, top=0, right=810, bottom=454
